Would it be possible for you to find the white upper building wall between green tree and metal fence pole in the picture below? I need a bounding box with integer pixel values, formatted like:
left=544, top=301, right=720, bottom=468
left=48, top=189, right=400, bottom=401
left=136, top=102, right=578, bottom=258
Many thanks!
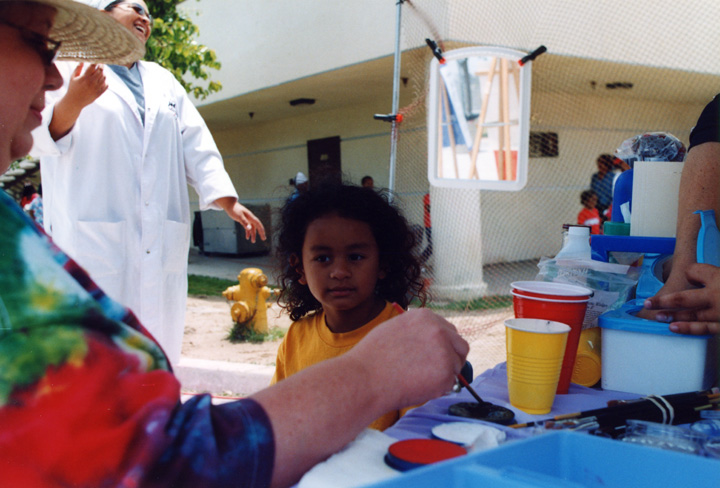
left=181, top=0, right=396, bottom=104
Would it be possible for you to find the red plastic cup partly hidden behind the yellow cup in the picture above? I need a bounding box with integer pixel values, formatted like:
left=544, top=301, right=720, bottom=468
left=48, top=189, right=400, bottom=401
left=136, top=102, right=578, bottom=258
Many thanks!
left=512, top=287, right=592, bottom=395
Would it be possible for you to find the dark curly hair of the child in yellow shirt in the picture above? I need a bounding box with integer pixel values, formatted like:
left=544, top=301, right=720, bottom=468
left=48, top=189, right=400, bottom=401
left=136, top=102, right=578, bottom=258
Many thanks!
left=277, top=182, right=427, bottom=321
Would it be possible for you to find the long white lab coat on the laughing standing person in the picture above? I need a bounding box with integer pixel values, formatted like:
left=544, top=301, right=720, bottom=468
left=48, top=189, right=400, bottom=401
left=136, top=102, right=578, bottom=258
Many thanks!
left=32, top=62, right=237, bottom=364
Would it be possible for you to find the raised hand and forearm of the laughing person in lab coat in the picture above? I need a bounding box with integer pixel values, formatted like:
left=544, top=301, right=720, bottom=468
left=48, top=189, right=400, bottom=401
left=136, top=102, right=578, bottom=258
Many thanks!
left=48, top=63, right=107, bottom=141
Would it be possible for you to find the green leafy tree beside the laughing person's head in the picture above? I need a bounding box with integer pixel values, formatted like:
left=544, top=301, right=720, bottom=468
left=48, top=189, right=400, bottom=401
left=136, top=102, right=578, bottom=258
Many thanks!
left=145, top=0, right=222, bottom=100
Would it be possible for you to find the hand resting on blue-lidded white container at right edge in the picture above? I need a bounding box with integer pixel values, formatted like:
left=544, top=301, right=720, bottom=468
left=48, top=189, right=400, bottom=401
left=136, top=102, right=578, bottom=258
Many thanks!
left=644, top=263, right=720, bottom=335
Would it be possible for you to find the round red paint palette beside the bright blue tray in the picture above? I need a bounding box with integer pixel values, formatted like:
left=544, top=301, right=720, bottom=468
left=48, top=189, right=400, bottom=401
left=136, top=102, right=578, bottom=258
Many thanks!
left=385, top=439, right=467, bottom=471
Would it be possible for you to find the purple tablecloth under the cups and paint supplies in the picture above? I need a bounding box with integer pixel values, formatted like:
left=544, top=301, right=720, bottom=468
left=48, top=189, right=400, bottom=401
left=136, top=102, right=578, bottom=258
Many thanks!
left=385, top=363, right=642, bottom=440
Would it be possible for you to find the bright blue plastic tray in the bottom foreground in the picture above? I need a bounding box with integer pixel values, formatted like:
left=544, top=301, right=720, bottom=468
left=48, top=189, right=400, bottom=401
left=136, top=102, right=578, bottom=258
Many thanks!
left=371, top=431, right=720, bottom=488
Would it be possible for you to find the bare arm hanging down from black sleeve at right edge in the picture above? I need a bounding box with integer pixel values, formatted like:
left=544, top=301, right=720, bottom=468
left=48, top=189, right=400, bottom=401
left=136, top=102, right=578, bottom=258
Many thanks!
left=639, top=142, right=720, bottom=319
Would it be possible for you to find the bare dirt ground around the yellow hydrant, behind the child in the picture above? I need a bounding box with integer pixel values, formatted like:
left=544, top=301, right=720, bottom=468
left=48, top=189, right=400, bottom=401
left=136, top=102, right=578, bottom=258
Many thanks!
left=182, top=297, right=508, bottom=374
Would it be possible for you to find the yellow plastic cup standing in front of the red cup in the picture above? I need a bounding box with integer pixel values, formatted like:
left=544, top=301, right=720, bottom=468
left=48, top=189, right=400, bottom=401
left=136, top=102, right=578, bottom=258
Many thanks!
left=505, top=319, right=570, bottom=415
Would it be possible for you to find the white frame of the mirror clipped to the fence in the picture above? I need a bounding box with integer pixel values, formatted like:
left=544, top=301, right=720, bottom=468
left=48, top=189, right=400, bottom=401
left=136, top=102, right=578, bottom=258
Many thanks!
left=427, top=46, right=532, bottom=191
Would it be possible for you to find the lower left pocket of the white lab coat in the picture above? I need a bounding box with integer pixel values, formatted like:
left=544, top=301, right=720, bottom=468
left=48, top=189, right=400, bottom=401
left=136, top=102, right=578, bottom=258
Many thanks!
left=75, top=221, right=127, bottom=282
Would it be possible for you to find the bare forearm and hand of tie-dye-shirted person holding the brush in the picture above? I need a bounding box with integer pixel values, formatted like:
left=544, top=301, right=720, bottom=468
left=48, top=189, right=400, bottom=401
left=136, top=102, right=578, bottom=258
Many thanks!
left=252, top=309, right=468, bottom=486
